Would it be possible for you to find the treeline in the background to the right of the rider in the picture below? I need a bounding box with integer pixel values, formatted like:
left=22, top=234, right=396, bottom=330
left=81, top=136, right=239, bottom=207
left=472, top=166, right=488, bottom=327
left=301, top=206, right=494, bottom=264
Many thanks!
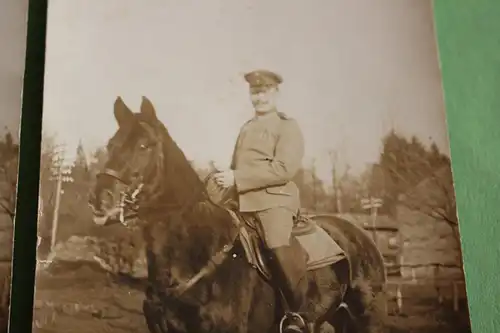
left=181, top=131, right=456, bottom=221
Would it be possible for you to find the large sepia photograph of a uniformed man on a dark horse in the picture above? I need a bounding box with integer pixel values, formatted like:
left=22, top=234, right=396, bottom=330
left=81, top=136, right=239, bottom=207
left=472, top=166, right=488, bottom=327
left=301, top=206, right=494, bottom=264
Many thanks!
left=32, top=0, right=471, bottom=333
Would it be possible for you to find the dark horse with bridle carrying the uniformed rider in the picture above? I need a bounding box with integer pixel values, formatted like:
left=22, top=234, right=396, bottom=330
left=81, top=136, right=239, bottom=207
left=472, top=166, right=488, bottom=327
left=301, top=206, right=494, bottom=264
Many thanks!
left=90, top=97, right=385, bottom=333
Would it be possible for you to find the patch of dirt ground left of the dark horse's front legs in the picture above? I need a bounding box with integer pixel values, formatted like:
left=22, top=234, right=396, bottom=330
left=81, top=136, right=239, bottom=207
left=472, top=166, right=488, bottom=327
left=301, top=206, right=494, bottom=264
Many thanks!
left=33, top=265, right=148, bottom=333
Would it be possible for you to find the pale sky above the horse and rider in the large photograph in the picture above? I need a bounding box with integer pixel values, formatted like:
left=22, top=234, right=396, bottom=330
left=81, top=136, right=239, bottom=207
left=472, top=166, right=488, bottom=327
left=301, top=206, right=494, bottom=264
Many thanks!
left=44, top=0, right=449, bottom=181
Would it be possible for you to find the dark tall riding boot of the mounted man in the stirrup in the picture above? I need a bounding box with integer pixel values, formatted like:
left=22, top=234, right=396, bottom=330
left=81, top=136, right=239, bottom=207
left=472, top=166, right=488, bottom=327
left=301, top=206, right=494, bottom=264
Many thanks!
left=271, top=239, right=308, bottom=333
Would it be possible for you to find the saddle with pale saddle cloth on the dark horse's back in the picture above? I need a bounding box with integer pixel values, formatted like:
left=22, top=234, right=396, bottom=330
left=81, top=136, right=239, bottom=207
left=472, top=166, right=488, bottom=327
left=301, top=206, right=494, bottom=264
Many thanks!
left=223, top=202, right=346, bottom=281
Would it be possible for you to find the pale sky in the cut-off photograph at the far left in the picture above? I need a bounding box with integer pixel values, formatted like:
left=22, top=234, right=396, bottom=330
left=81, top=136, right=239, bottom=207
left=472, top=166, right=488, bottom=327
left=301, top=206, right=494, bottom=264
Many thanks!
left=0, top=0, right=28, bottom=137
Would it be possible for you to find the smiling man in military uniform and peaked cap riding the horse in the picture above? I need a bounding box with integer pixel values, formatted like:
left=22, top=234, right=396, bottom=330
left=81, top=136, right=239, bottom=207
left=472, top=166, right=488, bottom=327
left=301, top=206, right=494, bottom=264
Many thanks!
left=215, top=70, right=307, bottom=332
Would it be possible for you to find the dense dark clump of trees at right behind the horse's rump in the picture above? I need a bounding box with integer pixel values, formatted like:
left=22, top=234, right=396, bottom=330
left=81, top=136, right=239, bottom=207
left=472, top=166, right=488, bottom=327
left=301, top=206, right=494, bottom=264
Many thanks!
left=376, top=132, right=455, bottom=219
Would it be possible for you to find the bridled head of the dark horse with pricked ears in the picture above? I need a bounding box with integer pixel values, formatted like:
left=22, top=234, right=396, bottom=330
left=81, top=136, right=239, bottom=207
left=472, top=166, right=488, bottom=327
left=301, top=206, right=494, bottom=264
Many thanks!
left=89, top=97, right=173, bottom=225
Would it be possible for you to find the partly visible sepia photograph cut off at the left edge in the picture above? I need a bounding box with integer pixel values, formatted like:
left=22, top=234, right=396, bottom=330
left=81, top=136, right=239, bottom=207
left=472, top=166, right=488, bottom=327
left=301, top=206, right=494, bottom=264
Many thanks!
left=0, top=0, right=28, bottom=332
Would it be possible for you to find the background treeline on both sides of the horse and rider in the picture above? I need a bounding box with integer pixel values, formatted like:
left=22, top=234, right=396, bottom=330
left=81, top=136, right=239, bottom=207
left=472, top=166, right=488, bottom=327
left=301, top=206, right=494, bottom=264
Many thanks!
left=37, top=131, right=456, bottom=244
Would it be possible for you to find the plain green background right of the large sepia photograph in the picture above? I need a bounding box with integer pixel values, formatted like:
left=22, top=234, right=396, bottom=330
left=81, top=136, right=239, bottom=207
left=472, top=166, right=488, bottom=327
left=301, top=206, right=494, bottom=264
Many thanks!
left=434, top=0, right=500, bottom=333
